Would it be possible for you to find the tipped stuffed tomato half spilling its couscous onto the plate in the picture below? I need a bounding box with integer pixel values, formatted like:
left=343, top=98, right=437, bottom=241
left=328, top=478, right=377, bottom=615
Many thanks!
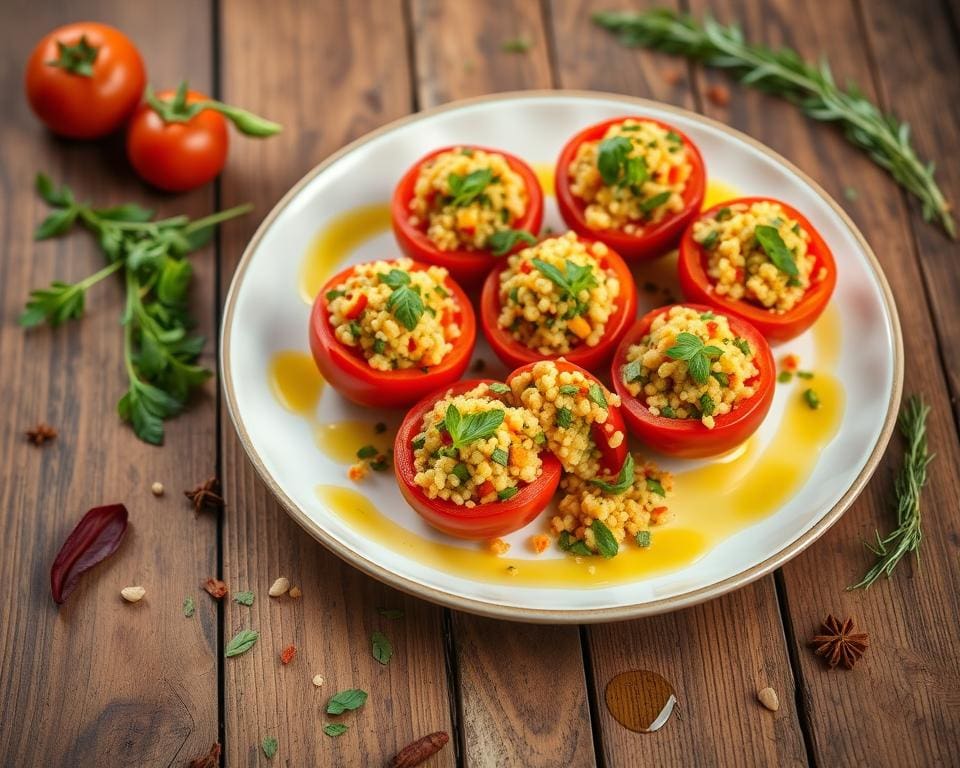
left=507, top=360, right=628, bottom=479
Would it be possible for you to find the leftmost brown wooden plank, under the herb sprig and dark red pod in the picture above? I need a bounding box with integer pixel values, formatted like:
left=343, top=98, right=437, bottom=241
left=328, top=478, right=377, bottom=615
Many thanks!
left=0, top=0, right=217, bottom=766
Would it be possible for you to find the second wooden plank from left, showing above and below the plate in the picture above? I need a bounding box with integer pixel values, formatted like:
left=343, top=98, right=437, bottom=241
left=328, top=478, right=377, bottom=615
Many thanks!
left=221, top=0, right=455, bottom=766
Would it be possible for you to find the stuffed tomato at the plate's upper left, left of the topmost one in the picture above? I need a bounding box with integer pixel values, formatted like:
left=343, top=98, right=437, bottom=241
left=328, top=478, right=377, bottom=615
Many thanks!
left=390, top=146, right=543, bottom=286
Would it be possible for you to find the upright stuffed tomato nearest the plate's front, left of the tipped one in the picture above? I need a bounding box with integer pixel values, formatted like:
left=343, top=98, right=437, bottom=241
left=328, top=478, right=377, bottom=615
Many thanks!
left=394, top=379, right=561, bottom=539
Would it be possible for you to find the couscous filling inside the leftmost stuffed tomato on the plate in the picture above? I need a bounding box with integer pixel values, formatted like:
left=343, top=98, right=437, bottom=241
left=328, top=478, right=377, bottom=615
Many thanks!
left=326, top=258, right=460, bottom=371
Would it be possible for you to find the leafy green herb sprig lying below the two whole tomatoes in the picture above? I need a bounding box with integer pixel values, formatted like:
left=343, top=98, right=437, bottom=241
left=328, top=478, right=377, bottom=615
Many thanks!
left=20, top=174, right=252, bottom=445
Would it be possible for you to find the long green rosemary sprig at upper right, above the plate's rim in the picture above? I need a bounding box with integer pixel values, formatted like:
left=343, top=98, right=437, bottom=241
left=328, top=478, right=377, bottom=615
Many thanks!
left=593, top=8, right=957, bottom=238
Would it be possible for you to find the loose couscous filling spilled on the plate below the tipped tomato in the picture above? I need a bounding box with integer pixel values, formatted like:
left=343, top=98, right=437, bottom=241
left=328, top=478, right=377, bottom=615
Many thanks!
left=550, top=454, right=673, bottom=557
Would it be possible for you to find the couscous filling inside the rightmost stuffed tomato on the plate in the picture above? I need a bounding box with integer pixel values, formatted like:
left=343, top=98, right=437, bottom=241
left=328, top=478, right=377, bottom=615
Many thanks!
left=693, top=200, right=824, bottom=313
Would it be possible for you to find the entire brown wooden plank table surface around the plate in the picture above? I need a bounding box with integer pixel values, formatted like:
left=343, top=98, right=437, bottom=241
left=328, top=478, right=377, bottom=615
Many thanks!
left=0, top=0, right=960, bottom=767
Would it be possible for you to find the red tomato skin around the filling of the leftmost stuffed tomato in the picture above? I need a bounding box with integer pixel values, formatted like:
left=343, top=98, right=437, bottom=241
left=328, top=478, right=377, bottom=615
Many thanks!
left=310, top=262, right=477, bottom=408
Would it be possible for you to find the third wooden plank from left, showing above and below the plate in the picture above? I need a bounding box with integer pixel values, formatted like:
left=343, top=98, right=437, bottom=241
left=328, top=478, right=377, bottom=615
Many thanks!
left=412, top=0, right=595, bottom=768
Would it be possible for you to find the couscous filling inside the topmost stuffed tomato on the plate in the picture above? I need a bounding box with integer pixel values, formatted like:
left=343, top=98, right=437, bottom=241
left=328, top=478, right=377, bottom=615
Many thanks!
left=569, top=119, right=693, bottom=234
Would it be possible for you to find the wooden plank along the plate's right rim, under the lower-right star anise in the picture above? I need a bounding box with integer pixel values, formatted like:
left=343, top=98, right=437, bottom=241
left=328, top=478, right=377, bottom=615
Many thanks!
left=694, top=0, right=960, bottom=766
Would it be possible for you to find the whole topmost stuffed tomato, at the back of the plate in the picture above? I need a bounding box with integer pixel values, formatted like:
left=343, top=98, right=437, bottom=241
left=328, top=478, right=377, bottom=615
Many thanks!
left=556, top=117, right=707, bottom=261
